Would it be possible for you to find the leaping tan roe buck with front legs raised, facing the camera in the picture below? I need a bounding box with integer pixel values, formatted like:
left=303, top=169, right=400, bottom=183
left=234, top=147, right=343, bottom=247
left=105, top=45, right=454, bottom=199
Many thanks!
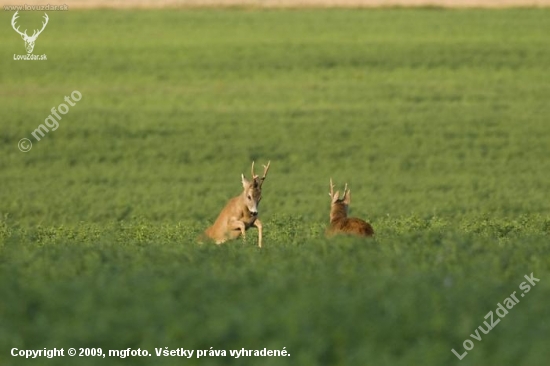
left=204, top=162, right=271, bottom=248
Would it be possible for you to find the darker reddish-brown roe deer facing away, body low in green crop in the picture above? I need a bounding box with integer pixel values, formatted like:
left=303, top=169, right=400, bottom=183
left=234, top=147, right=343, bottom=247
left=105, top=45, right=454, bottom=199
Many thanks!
left=326, top=178, right=374, bottom=237
